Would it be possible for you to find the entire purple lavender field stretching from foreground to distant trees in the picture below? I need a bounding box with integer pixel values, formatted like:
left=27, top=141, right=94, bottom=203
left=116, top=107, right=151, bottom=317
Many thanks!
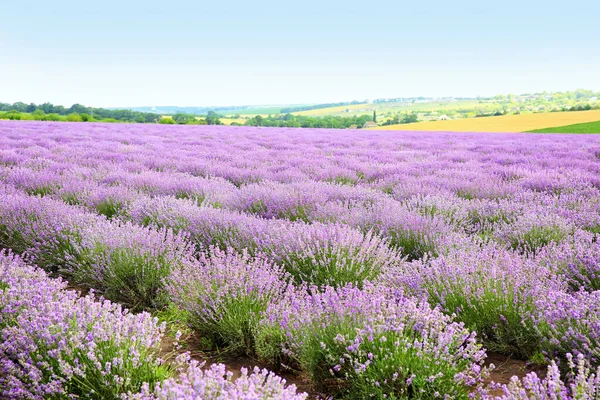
left=0, top=121, right=600, bottom=400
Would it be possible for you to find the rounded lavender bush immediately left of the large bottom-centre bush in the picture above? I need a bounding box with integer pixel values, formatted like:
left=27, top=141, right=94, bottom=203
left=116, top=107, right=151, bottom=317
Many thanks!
left=166, top=248, right=287, bottom=355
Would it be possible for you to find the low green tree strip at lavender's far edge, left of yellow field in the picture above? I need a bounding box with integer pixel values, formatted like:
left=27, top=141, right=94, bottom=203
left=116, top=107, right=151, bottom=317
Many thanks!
left=241, top=113, right=373, bottom=129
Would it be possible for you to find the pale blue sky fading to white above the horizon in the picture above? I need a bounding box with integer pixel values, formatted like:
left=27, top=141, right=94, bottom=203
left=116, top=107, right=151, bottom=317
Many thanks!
left=0, top=0, right=600, bottom=107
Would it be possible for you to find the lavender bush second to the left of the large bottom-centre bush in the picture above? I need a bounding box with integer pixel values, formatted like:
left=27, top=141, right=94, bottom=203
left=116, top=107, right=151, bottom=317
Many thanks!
left=69, top=222, right=192, bottom=309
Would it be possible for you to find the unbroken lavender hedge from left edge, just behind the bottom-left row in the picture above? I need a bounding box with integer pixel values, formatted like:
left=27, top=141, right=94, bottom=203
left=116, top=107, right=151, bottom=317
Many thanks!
left=0, top=193, right=192, bottom=309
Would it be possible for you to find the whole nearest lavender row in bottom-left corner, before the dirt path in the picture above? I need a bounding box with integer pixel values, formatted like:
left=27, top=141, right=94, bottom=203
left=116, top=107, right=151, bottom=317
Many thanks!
left=0, top=251, right=306, bottom=400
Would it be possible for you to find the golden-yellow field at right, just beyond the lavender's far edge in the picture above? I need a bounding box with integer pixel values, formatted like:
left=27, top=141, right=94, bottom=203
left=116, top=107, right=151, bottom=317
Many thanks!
left=370, top=110, right=600, bottom=132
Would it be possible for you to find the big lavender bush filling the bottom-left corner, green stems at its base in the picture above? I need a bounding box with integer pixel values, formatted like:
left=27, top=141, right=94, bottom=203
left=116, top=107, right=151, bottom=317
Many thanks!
left=0, top=252, right=170, bottom=399
